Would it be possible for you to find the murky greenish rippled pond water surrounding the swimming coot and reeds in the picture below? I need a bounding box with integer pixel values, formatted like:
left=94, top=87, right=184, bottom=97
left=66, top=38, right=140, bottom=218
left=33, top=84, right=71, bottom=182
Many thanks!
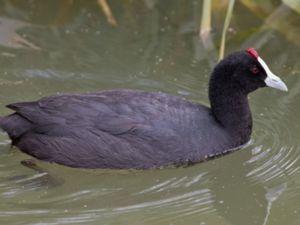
left=0, top=0, right=300, bottom=225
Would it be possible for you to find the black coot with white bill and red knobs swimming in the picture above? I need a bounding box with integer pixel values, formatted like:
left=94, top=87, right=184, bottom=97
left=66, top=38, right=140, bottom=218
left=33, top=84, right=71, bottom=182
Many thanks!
left=0, top=48, right=287, bottom=169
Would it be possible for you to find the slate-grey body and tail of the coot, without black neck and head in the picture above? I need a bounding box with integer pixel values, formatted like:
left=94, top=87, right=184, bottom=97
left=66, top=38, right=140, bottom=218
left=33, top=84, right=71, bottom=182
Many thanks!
left=0, top=90, right=228, bottom=168
